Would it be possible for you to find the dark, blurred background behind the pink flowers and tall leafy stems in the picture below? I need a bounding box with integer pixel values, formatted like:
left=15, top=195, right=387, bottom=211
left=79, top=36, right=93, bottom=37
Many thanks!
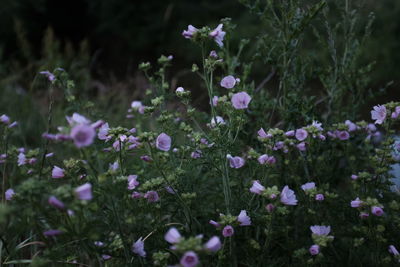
left=0, top=0, right=400, bottom=146
